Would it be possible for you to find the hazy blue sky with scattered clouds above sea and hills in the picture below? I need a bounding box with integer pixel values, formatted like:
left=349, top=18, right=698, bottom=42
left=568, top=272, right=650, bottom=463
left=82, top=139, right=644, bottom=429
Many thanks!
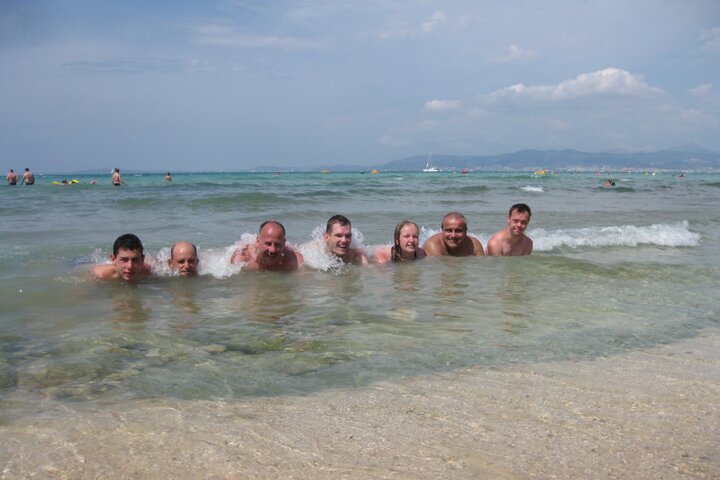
left=0, top=0, right=720, bottom=173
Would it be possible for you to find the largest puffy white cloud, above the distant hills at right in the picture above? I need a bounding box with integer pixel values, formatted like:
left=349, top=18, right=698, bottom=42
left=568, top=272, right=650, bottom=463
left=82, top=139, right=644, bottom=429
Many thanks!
left=484, top=68, right=664, bottom=103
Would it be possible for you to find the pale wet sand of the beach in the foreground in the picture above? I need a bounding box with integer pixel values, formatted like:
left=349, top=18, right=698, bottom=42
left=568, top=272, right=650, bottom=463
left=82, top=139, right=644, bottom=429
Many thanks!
left=0, top=331, right=720, bottom=479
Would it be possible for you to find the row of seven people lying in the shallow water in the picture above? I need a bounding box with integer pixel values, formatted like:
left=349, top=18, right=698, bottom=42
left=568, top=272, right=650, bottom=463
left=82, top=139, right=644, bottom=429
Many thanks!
left=91, top=203, right=533, bottom=282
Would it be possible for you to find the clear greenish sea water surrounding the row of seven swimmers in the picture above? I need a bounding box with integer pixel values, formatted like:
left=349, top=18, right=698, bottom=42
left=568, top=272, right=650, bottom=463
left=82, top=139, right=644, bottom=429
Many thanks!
left=0, top=172, right=720, bottom=412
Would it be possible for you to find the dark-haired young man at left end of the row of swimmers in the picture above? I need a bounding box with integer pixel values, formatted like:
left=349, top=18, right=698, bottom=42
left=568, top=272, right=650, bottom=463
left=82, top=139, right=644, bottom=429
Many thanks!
left=92, top=233, right=150, bottom=282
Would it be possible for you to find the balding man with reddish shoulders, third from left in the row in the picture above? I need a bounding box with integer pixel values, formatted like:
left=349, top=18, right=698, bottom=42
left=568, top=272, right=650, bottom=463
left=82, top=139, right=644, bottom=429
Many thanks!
left=230, top=220, right=303, bottom=272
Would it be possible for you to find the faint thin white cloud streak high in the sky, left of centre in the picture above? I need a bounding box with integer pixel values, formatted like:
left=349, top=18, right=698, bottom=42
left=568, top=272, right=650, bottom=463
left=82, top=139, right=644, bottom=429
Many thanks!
left=192, top=24, right=321, bottom=50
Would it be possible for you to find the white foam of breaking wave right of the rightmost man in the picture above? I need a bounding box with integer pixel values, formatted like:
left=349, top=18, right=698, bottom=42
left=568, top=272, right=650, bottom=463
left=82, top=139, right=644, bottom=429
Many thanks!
left=528, top=221, right=700, bottom=252
